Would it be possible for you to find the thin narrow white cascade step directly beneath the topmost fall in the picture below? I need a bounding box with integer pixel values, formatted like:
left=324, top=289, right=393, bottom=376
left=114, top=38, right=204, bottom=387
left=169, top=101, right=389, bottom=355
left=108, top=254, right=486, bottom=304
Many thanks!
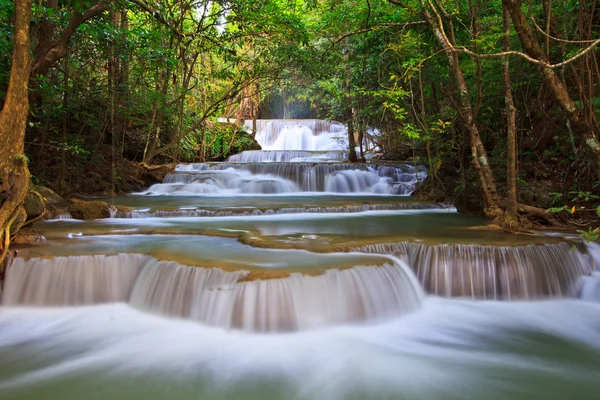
left=227, top=150, right=348, bottom=163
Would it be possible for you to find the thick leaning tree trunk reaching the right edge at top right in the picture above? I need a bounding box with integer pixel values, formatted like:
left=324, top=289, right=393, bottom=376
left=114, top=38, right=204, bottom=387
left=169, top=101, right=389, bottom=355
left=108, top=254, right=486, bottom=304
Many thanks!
left=502, top=0, right=600, bottom=179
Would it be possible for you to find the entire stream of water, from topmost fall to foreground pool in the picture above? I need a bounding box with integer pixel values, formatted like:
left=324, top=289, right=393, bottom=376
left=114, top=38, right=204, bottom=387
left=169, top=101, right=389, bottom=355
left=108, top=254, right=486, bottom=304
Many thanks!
left=0, top=120, right=600, bottom=400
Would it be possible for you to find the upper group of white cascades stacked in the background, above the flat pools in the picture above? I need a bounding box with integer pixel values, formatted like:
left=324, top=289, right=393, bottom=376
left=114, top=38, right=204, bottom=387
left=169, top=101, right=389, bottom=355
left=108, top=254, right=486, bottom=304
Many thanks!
left=146, top=120, right=427, bottom=195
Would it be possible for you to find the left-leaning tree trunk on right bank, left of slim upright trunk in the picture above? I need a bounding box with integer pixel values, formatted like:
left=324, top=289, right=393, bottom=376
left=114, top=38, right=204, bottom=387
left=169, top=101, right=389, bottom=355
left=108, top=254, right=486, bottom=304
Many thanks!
left=421, top=0, right=502, bottom=217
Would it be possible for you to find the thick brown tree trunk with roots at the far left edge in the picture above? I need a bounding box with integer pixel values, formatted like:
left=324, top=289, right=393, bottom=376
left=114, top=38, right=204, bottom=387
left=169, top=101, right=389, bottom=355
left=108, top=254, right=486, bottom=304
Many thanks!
left=0, top=0, right=32, bottom=272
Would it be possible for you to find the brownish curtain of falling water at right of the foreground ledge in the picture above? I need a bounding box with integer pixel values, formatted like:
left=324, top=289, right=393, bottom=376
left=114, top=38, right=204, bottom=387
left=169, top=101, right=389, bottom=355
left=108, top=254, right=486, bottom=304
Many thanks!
left=354, top=242, right=593, bottom=300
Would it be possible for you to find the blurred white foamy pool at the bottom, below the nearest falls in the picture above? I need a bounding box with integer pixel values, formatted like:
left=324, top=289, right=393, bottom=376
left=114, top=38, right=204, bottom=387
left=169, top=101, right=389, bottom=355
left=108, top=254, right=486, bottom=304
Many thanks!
left=0, top=299, right=600, bottom=400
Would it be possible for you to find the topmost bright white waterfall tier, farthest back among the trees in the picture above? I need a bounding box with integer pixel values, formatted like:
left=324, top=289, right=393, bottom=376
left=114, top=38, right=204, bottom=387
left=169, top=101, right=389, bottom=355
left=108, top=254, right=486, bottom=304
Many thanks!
left=246, top=119, right=348, bottom=151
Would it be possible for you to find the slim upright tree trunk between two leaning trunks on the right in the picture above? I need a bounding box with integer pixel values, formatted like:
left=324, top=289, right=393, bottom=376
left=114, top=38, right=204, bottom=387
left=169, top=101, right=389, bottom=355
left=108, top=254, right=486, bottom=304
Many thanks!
left=502, top=7, right=518, bottom=227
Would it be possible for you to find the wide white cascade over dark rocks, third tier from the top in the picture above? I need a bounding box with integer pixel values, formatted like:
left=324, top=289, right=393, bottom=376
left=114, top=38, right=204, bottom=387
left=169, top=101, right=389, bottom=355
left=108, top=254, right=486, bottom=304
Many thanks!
left=142, top=162, right=427, bottom=195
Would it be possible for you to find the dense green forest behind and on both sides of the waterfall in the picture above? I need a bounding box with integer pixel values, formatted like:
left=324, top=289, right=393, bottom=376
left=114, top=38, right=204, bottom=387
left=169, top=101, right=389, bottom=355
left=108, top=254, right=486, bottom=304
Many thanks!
left=0, top=0, right=600, bottom=230
